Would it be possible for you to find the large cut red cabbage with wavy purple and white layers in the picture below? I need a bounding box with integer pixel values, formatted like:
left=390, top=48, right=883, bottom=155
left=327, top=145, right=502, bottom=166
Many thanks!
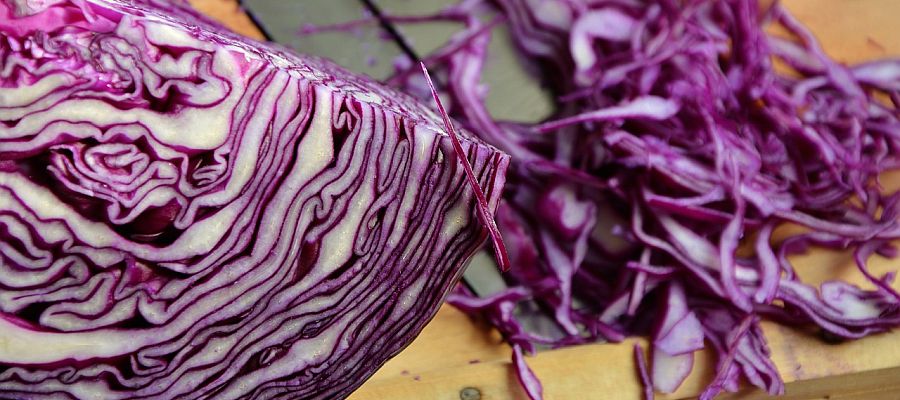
left=0, top=0, right=508, bottom=399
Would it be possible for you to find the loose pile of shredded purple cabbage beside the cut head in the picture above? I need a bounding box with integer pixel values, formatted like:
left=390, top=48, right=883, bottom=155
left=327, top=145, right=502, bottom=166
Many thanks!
left=314, top=0, right=900, bottom=399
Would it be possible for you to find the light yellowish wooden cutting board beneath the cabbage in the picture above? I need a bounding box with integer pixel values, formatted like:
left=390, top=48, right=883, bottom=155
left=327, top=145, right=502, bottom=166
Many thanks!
left=191, top=0, right=900, bottom=400
